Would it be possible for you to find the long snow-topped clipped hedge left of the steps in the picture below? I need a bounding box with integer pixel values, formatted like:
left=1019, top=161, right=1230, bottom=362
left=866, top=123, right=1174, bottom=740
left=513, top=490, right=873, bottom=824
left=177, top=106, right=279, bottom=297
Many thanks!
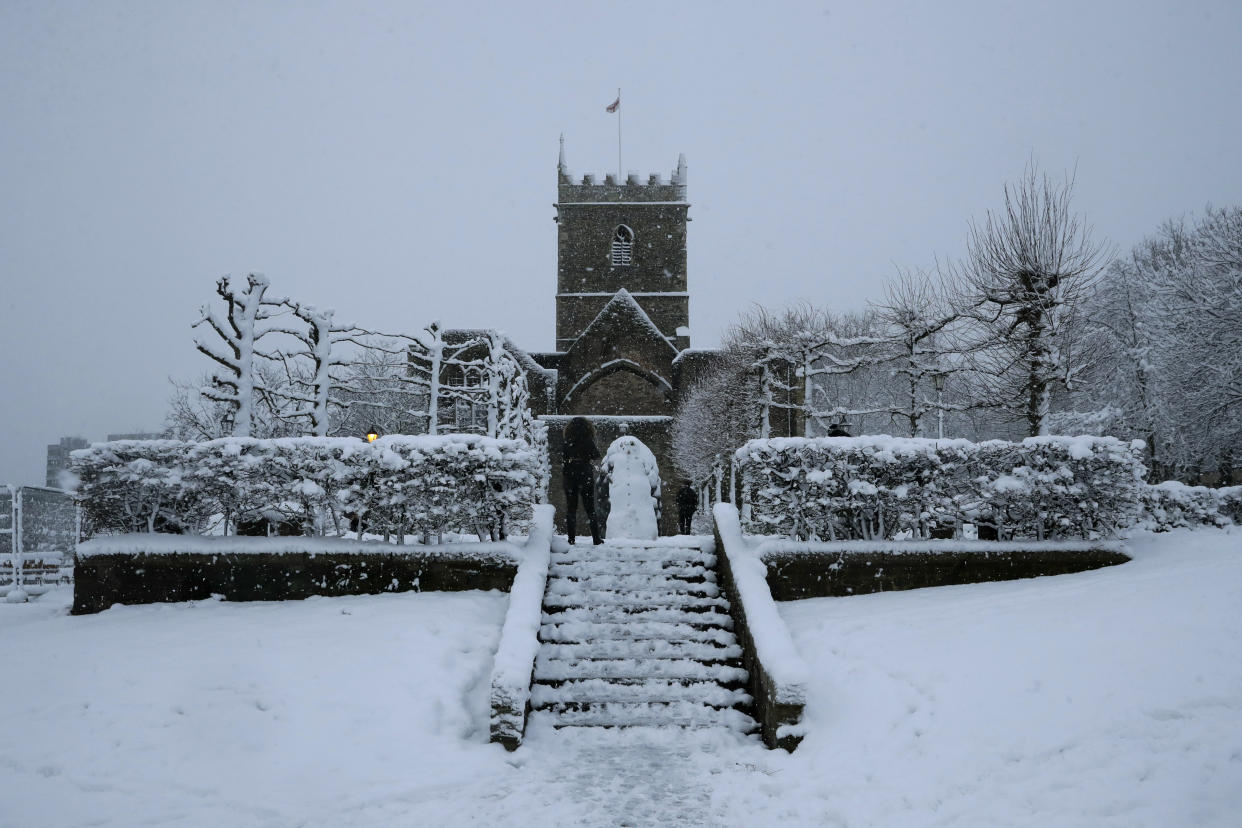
left=71, top=434, right=539, bottom=535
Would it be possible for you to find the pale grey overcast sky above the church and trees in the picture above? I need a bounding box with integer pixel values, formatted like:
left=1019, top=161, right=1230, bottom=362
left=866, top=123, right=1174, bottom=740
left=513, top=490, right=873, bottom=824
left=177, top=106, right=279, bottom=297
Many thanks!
left=0, top=0, right=1242, bottom=484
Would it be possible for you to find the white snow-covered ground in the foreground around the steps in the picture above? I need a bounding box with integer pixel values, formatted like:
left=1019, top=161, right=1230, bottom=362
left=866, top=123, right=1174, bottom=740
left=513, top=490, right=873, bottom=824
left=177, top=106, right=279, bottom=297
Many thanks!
left=0, top=529, right=1242, bottom=828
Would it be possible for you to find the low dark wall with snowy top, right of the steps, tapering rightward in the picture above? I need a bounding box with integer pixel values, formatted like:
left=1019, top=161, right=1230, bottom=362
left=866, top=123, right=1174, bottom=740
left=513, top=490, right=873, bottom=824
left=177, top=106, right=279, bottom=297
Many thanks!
left=758, top=540, right=1130, bottom=601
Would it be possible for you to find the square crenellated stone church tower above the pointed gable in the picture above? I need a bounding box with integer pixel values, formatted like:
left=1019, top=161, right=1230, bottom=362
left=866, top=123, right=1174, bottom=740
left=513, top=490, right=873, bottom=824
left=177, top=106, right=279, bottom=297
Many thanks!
left=556, top=138, right=691, bottom=353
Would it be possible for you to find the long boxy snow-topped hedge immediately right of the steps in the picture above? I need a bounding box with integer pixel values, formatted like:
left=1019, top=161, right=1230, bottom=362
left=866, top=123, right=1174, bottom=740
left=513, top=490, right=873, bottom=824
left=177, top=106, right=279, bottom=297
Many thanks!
left=735, top=436, right=1144, bottom=540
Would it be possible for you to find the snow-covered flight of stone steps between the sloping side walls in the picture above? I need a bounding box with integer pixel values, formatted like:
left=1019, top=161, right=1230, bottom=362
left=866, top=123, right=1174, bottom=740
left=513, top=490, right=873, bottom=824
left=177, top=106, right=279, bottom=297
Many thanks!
left=530, top=541, right=756, bottom=732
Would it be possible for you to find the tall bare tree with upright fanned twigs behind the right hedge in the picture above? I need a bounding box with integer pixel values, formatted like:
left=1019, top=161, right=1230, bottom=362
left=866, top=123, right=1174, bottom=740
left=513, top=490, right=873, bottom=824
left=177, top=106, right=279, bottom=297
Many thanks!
left=956, top=164, right=1105, bottom=436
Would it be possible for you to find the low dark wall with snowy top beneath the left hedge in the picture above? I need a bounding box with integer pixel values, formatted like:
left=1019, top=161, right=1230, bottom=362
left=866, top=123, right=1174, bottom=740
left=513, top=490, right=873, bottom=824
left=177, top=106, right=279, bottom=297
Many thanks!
left=72, top=534, right=520, bottom=614
